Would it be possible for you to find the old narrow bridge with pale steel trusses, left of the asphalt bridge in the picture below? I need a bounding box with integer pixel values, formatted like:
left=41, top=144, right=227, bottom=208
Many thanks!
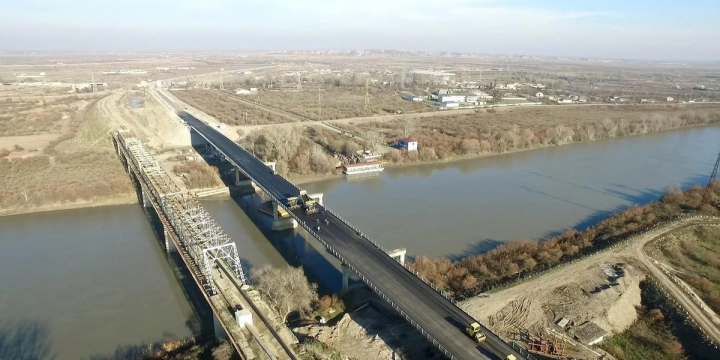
left=112, top=129, right=296, bottom=360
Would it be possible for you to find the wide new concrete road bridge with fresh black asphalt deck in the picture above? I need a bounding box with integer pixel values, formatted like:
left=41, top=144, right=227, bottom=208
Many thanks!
left=178, top=116, right=527, bottom=359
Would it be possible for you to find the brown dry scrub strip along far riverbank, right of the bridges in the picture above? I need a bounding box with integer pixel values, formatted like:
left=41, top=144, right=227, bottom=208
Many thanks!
left=336, top=104, right=720, bottom=162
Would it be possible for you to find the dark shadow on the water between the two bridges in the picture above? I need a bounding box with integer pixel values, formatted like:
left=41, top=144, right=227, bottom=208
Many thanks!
left=190, top=131, right=342, bottom=295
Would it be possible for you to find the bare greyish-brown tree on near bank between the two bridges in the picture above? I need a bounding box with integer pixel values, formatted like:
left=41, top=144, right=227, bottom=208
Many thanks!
left=251, top=265, right=318, bottom=320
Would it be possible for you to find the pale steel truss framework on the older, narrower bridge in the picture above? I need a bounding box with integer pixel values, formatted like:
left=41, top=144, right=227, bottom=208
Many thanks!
left=113, top=130, right=247, bottom=295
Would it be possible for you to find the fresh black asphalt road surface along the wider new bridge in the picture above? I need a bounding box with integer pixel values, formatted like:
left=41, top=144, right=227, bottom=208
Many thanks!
left=178, top=111, right=524, bottom=360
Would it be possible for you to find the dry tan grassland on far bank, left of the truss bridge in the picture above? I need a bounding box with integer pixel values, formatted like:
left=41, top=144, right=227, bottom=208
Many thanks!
left=0, top=97, right=133, bottom=210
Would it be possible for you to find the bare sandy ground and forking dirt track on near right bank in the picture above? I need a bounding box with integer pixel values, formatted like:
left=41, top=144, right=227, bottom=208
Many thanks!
left=462, top=218, right=720, bottom=352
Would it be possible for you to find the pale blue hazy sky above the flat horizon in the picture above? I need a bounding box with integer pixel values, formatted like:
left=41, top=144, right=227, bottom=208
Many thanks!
left=0, top=0, right=720, bottom=61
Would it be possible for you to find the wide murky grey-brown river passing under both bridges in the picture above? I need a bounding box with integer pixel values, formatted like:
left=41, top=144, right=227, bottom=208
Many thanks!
left=0, top=127, right=720, bottom=360
